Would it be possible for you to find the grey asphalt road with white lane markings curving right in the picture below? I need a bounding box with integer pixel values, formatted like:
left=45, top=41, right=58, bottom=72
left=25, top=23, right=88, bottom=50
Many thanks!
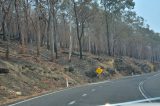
left=9, top=72, right=160, bottom=106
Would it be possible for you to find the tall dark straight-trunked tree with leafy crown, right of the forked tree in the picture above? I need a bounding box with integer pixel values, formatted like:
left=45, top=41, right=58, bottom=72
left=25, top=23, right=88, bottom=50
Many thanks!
left=101, top=0, right=135, bottom=56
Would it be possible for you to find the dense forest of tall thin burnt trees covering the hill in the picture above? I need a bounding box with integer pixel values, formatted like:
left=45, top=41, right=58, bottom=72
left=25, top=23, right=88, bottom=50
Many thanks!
left=0, top=0, right=160, bottom=62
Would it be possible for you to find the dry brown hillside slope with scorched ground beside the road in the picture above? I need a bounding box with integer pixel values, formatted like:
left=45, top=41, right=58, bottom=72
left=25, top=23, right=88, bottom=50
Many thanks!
left=0, top=42, right=155, bottom=104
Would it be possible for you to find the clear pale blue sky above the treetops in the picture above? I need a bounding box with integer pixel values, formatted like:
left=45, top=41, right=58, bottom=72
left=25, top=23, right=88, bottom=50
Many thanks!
left=134, top=0, right=160, bottom=33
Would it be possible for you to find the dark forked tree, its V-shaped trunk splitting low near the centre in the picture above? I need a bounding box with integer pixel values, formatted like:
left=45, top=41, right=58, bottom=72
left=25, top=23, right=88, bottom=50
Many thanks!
left=72, top=0, right=92, bottom=59
